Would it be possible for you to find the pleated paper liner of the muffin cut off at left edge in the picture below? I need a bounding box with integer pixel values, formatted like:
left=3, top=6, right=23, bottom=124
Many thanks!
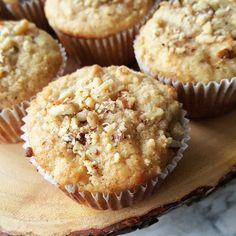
left=0, top=43, right=67, bottom=144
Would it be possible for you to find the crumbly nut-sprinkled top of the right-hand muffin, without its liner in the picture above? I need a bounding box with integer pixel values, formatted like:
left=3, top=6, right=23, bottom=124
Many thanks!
left=134, top=0, right=236, bottom=83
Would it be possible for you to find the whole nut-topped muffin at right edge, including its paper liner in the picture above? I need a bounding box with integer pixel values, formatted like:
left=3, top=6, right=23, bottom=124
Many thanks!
left=134, top=0, right=236, bottom=117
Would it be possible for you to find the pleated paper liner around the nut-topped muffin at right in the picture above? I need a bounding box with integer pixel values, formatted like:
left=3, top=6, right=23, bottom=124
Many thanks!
left=136, top=51, right=236, bottom=118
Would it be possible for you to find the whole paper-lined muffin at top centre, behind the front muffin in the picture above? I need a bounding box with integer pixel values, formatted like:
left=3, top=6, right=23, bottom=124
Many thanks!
left=45, top=0, right=157, bottom=65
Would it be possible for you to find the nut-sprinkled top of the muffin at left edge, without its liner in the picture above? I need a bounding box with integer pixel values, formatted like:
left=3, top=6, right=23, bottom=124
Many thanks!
left=0, top=20, right=62, bottom=109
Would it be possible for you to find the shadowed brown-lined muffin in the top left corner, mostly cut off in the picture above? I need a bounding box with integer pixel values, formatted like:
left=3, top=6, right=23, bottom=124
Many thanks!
left=3, top=0, right=52, bottom=33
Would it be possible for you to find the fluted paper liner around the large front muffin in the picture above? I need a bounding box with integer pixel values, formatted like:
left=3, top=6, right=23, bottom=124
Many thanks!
left=21, top=110, right=190, bottom=210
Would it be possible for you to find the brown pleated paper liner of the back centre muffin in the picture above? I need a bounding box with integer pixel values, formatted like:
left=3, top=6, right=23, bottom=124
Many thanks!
left=48, top=0, right=160, bottom=66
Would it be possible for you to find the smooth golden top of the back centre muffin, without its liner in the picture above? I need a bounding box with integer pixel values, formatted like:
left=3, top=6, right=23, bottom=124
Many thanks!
left=45, top=0, right=154, bottom=38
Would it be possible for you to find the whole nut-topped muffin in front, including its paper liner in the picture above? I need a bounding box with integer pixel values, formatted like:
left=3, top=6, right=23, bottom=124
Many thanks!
left=23, top=65, right=188, bottom=210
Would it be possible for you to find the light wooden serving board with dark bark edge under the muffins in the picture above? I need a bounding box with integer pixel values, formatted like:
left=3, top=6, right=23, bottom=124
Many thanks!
left=0, top=110, right=236, bottom=236
